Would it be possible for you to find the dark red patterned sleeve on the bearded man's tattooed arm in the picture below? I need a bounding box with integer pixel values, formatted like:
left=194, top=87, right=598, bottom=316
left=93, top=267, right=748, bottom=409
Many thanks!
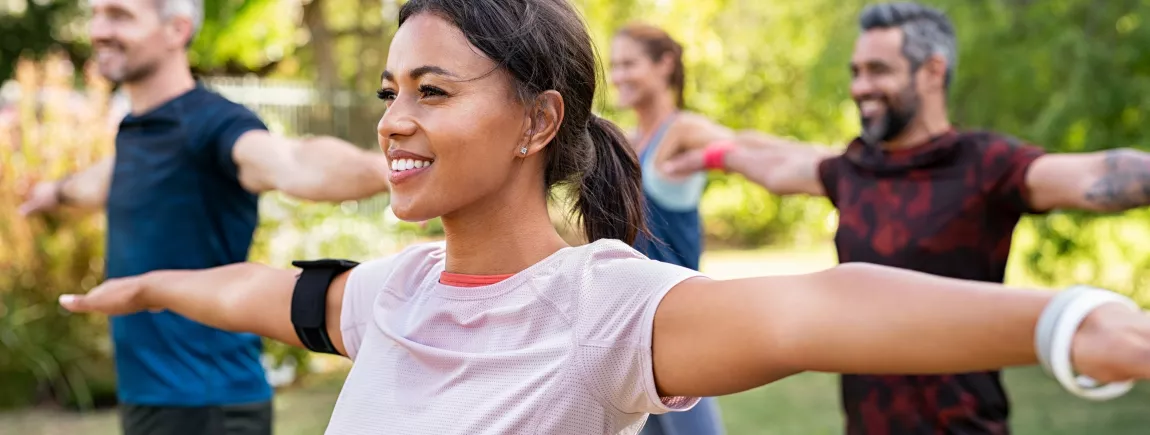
left=982, top=135, right=1045, bottom=214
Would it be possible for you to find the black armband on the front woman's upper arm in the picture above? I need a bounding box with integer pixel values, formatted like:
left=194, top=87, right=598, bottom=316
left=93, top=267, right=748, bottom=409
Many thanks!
left=291, top=259, right=359, bottom=354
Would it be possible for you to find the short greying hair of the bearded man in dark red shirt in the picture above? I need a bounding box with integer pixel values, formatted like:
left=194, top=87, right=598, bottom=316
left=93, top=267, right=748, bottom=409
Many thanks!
left=859, top=2, right=958, bottom=87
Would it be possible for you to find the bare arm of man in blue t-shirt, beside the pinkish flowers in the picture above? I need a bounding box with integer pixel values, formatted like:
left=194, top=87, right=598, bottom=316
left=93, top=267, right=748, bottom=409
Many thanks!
left=20, top=157, right=115, bottom=215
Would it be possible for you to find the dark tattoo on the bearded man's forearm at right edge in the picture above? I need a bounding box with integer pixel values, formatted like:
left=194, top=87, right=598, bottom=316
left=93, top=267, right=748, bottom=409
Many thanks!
left=1086, top=150, right=1150, bottom=212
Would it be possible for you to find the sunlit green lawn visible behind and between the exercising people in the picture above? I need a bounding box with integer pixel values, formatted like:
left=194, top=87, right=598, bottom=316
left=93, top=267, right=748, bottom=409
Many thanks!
left=0, top=245, right=1150, bottom=435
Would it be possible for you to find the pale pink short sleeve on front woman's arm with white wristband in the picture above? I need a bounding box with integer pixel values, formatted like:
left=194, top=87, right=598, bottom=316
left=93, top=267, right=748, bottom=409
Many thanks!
left=576, top=242, right=700, bottom=414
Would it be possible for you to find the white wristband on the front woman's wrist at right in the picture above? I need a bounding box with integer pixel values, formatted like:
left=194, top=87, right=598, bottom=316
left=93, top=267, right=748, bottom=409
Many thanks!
left=1048, top=290, right=1140, bottom=400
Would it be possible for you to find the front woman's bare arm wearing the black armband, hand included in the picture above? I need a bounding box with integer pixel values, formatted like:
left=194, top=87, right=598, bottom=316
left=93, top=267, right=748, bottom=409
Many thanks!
left=60, top=262, right=351, bottom=354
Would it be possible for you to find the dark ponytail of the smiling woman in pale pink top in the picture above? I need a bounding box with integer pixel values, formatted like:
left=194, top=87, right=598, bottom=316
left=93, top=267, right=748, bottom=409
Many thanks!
left=584, top=115, right=646, bottom=244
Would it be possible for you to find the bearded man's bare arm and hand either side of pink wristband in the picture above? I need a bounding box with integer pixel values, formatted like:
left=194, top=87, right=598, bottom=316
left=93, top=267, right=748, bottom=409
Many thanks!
left=662, top=131, right=835, bottom=196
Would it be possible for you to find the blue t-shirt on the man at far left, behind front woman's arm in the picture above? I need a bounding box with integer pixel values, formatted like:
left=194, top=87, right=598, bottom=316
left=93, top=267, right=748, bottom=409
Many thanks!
left=106, top=84, right=271, bottom=406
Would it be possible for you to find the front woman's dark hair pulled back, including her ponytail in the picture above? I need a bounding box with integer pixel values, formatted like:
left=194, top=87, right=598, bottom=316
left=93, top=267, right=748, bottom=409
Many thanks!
left=399, top=0, right=646, bottom=243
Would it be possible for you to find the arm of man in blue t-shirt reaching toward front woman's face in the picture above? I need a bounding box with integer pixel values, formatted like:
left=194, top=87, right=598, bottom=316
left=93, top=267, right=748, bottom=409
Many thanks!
left=232, top=130, right=389, bottom=201
